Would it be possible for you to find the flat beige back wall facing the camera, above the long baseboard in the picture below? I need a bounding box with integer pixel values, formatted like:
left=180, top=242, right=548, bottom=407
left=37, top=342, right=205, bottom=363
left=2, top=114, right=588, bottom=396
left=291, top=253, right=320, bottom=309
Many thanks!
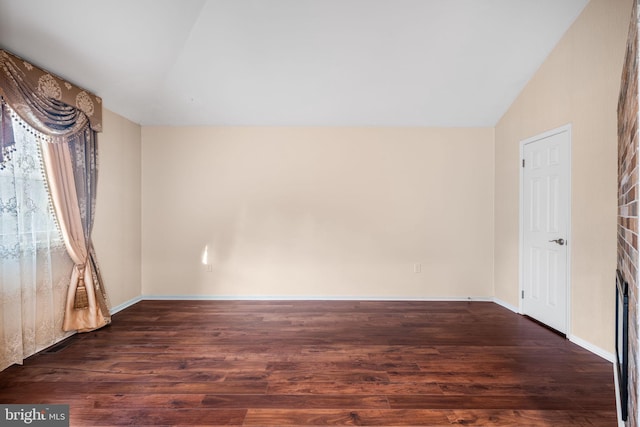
left=142, top=127, right=494, bottom=298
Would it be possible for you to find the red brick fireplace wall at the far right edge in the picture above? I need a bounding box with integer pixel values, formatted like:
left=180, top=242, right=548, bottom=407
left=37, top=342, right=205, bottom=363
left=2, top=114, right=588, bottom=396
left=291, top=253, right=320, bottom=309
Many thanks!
left=612, top=0, right=640, bottom=427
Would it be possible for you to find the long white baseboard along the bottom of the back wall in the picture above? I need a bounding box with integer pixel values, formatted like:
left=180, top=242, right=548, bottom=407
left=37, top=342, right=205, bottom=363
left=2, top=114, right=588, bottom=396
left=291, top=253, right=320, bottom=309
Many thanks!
left=140, top=295, right=494, bottom=302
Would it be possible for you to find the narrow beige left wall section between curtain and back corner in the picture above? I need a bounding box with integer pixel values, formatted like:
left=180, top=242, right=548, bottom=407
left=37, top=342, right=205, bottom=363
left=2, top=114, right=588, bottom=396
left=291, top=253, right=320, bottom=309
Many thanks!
left=93, top=110, right=141, bottom=307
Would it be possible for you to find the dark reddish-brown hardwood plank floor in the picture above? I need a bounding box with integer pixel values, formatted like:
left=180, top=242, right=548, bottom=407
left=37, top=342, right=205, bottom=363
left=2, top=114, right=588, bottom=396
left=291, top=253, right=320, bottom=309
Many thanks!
left=0, top=301, right=617, bottom=427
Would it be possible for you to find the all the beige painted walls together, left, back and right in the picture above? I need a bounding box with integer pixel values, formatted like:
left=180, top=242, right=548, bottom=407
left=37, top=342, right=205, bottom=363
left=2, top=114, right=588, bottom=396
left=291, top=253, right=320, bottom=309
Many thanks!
left=94, top=0, right=631, bottom=358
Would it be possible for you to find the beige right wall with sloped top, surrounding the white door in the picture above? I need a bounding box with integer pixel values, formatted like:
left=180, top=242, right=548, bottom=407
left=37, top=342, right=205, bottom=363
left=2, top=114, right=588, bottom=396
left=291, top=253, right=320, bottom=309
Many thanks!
left=495, top=0, right=632, bottom=352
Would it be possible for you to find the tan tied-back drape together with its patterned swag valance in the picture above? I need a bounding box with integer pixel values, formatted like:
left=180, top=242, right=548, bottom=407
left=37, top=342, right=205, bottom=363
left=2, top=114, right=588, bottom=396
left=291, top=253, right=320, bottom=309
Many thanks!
left=0, top=50, right=111, bottom=331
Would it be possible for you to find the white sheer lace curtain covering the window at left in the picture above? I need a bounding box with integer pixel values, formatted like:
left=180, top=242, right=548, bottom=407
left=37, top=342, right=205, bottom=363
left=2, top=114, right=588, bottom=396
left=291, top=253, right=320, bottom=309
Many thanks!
left=0, top=112, right=73, bottom=370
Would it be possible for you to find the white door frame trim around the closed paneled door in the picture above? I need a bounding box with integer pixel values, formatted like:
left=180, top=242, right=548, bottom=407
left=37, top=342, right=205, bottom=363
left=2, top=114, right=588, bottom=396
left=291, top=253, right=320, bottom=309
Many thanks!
left=518, top=123, right=573, bottom=338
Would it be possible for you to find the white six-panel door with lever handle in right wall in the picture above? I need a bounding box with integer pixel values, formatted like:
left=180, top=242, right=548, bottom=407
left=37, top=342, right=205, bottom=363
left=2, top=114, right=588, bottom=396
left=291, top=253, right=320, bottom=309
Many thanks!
left=520, top=127, right=571, bottom=333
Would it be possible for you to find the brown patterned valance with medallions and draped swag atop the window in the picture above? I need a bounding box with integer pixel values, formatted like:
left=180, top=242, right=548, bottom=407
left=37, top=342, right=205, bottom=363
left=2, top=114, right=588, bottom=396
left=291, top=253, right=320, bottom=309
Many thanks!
left=0, top=50, right=102, bottom=134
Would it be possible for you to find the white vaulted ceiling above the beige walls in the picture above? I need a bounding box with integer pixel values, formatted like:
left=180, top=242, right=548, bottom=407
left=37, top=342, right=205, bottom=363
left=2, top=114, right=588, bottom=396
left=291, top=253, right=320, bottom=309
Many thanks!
left=0, top=0, right=588, bottom=127
